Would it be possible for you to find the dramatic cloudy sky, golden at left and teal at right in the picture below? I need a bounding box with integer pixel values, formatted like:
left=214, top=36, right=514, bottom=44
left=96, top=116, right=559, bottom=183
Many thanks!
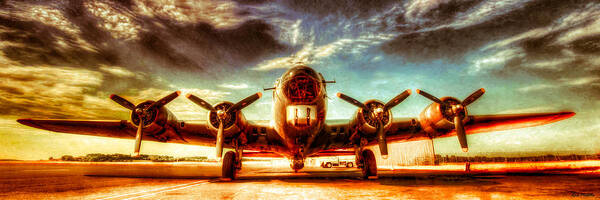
left=0, top=0, right=600, bottom=159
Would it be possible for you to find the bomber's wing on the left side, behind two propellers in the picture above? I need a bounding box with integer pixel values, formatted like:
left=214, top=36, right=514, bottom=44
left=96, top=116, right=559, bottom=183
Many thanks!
left=17, top=119, right=271, bottom=148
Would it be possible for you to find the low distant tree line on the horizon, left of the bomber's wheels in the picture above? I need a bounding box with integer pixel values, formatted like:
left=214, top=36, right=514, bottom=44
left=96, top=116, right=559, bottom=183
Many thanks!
left=54, top=153, right=209, bottom=162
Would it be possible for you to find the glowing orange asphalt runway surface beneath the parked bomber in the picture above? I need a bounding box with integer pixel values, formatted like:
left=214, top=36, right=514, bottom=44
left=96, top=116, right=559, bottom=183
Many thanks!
left=0, top=162, right=600, bottom=200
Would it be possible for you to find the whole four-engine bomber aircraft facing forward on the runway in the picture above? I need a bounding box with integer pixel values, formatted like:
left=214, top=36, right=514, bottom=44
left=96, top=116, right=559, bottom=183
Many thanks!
left=17, top=65, right=575, bottom=179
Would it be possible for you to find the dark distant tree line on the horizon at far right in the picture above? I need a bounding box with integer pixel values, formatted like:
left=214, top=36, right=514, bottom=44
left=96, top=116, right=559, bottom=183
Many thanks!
left=435, top=154, right=600, bottom=163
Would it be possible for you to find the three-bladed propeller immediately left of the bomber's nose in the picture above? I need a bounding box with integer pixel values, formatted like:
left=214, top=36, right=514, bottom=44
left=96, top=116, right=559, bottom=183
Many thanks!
left=186, top=92, right=262, bottom=159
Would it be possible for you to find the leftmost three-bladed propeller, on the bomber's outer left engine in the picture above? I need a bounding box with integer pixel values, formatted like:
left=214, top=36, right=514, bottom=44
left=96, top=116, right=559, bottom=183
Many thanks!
left=110, top=91, right=181, bottom=156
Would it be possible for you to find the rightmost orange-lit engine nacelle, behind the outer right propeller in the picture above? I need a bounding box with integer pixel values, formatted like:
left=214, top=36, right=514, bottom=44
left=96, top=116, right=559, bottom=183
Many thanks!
left=419, top=97, right=469, bottom=137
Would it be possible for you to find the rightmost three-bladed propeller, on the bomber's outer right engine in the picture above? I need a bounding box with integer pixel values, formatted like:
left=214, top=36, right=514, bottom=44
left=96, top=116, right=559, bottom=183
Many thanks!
left=417, top=88, right=485, bottom=152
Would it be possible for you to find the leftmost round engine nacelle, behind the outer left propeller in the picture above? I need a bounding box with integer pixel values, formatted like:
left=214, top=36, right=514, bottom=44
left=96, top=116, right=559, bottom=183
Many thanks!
left=131, top=101, right=177, bottom=137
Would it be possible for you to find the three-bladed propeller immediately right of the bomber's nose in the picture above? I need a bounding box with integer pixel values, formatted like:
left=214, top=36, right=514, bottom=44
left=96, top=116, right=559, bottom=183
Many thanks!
left=337, top=90, right=411, bottom=159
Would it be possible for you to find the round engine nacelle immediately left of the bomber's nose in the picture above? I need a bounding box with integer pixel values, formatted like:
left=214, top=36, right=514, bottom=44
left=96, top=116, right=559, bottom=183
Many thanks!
left=207, top=101, right=247, bottom=138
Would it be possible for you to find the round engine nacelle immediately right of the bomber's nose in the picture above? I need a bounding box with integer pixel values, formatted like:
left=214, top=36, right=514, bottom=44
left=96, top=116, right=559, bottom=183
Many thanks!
left=350, top=99, right=393, bottom=137
